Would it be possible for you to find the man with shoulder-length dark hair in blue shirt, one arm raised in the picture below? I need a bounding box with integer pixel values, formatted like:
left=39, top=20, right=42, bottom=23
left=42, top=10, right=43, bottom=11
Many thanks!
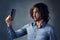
left=5, top=3, right=56, bottom=40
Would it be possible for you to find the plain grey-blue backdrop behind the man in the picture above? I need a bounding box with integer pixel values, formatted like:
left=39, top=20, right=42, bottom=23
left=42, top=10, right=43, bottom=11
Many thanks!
left=0, top=0, right=60, bottom=40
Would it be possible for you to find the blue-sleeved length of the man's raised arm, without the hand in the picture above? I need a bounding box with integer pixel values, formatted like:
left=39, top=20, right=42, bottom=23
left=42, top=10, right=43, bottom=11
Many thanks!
left=7, top=26, right=27, bottom=39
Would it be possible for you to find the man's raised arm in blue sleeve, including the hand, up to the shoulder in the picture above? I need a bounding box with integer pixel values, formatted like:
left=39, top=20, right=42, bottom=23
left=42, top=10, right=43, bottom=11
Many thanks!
left=5, top=15, right=27, bottom=39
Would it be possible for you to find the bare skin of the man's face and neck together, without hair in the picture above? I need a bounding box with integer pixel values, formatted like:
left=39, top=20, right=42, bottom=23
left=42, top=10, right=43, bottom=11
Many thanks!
left=33, top=8, right=43, bottom=27
